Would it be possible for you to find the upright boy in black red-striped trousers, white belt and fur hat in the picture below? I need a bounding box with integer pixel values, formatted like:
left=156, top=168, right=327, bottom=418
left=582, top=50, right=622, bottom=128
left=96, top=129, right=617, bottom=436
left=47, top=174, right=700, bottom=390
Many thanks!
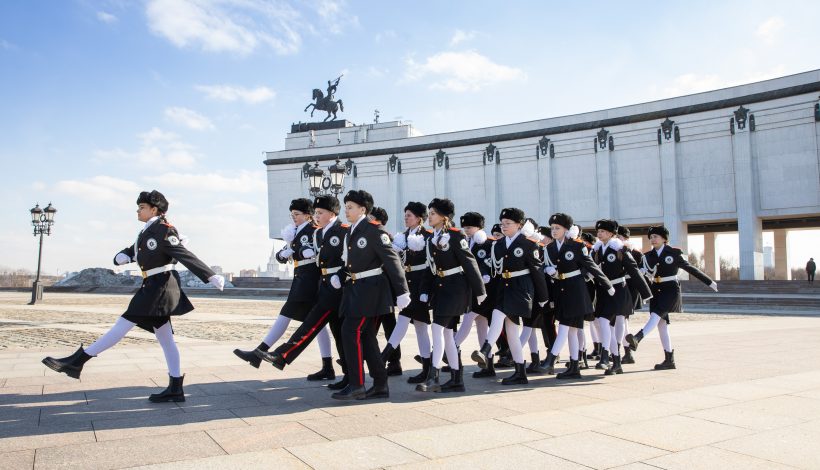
left=331, top=190, right=410, bottom=400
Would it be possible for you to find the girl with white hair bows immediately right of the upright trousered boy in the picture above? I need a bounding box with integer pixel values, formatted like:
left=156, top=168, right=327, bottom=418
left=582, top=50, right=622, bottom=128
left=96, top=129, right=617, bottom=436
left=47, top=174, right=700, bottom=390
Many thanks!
left=382, top=201, right=433, bottom=384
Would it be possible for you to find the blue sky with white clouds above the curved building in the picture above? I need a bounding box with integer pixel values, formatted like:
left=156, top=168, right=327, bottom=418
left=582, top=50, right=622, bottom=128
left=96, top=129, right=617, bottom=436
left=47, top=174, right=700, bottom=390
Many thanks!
left=0, top=0, right=820, bottom=274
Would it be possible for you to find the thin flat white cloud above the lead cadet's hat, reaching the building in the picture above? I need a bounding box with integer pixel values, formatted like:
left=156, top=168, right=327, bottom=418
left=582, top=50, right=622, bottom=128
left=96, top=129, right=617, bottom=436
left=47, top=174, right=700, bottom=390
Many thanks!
left=145, top=170, right=267, bottom=194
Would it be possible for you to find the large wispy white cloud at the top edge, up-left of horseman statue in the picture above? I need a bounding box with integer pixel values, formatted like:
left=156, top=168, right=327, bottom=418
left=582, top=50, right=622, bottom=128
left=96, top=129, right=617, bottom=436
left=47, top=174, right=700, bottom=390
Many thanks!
left=146, top=0, right=302, bottom=55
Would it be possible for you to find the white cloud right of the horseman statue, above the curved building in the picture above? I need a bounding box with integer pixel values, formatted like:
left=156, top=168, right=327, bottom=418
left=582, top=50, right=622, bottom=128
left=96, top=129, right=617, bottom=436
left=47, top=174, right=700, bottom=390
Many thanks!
left=404, top=51, right=527, bottom=92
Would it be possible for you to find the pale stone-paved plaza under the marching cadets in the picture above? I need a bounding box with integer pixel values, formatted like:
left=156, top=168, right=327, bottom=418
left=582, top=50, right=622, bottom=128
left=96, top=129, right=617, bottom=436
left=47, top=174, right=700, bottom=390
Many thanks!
left=0, top=292, right=820, bottom=470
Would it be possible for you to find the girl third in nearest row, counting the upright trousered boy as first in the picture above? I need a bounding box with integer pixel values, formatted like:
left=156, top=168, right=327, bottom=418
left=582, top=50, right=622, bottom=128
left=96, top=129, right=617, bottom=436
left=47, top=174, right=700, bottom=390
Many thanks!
left=472, top=207, right=549, bottom=385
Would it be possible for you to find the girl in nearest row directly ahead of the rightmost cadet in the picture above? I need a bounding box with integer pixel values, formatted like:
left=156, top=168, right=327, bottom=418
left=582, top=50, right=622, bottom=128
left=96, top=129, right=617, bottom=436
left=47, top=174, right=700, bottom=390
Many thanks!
left=592, top=219, right=651, bottom=375
